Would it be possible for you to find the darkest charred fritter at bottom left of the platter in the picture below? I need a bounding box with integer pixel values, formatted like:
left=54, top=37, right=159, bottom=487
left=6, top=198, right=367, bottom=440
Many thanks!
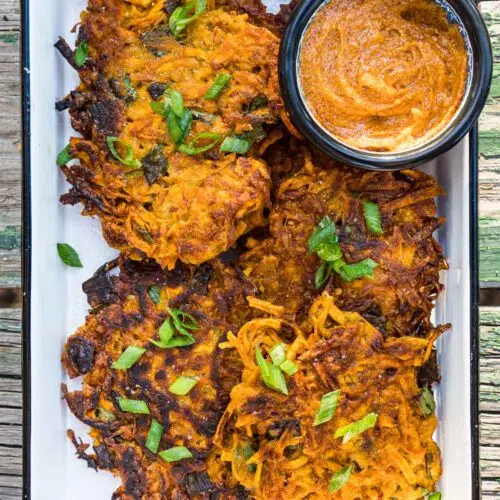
left=63, top=261, right=253, bottom=499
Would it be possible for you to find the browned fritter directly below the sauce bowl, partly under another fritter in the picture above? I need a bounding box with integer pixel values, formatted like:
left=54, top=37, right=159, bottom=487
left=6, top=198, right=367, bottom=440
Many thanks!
left=241, top=142, right=447, bottom=336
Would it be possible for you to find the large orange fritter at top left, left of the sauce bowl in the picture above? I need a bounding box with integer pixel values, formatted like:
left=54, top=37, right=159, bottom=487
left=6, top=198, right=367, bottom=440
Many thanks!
left=57, top=0, right=281, bottom=269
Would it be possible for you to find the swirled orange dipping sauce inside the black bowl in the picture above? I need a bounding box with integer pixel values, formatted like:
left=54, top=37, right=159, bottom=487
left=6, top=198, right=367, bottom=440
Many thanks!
left=299, top=0, right=468, bottom=152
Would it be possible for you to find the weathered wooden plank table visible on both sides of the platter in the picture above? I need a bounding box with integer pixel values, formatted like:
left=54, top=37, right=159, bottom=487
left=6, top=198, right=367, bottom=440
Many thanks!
left=0, top=0, right=500, bottom=500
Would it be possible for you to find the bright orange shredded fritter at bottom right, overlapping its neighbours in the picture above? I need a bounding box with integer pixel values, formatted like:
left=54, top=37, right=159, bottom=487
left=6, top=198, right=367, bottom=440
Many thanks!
left=209, top=292, right=440, bottom=500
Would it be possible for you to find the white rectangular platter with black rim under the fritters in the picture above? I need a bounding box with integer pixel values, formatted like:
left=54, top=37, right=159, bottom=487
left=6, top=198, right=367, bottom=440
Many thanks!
left=24, top=0, right=479, bottom=500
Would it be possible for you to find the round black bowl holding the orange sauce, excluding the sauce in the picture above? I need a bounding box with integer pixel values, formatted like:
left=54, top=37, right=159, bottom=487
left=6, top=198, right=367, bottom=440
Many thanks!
left=279, top=0, right=493, bottom=170
